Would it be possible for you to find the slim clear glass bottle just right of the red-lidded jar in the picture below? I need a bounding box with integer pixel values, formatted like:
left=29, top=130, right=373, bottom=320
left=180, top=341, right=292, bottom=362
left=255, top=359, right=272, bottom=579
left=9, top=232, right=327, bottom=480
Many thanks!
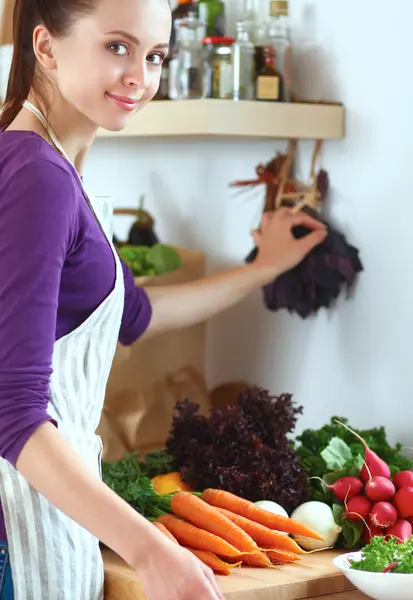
left=232, top=21, right=255, bottom=100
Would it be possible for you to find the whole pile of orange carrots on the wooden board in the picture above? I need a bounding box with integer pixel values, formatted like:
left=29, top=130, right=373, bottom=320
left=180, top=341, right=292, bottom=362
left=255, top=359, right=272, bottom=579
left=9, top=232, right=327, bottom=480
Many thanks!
left=151, top=489, right=321, bottom=575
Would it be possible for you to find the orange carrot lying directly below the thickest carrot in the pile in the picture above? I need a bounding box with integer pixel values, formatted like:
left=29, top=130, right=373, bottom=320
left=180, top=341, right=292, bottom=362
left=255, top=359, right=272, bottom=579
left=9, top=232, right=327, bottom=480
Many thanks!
left=157, top=514, right=249, bottom=558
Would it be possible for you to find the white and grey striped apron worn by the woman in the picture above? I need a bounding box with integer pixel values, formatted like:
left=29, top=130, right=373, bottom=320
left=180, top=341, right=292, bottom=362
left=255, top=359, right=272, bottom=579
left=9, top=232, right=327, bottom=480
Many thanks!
left=0, top=105, right=124, bottom=600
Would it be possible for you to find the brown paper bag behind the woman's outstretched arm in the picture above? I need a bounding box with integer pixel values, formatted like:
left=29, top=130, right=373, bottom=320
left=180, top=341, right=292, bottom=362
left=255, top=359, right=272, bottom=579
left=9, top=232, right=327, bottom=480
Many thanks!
left=98, top=248, right=209, bottom=460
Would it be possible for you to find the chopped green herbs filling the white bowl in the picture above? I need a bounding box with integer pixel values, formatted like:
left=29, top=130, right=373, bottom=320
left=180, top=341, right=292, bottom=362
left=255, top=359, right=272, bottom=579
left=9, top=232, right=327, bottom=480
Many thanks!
left=349, top=536, right=413, bottom=573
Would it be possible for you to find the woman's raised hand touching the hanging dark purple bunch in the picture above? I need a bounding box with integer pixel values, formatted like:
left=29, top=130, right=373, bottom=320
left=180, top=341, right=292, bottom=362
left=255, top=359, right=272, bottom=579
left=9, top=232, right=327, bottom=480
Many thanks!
left=252, top=208, right=327, bottom=280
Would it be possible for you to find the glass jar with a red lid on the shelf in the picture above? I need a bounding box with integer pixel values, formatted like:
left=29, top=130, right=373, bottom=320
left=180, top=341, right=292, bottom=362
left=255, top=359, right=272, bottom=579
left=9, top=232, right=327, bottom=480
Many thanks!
left=204, top=36, right=235, bottom=100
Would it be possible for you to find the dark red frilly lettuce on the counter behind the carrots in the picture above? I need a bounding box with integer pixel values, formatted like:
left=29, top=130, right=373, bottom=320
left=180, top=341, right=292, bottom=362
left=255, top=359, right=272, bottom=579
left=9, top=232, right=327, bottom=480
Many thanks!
left=166, top=387, right=309, bottom=512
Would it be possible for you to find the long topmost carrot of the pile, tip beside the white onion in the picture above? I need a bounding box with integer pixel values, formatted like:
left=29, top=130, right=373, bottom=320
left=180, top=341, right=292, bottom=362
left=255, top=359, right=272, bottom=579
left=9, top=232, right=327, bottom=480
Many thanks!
left=201, top=488, right=324, bottom=541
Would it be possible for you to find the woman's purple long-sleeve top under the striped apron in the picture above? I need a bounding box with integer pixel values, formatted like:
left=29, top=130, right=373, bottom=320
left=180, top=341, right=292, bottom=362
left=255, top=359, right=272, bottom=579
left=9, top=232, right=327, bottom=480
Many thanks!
left=0, top=131, right=151, bottom=541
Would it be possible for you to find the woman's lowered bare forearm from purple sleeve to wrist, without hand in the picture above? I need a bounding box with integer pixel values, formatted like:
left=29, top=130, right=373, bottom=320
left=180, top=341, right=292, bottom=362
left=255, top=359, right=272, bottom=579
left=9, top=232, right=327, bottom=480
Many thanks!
left=16, top=423, right=159, bottom=569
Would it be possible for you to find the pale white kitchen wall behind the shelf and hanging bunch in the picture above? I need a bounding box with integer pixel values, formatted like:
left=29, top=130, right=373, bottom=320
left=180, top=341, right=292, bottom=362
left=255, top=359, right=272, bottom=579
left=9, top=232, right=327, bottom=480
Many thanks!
left=83, top=0, right=413, bottom=446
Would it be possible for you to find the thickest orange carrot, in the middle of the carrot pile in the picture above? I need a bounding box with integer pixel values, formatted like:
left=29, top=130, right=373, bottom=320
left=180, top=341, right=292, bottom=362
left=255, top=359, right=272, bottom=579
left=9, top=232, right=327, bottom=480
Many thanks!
left=171, top=492, right=258, bottom=552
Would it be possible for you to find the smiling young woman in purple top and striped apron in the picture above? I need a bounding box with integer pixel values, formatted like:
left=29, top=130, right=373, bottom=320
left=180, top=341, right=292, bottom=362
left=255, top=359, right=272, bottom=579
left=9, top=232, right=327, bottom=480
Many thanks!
left=0, top=0, right=325, bottom=600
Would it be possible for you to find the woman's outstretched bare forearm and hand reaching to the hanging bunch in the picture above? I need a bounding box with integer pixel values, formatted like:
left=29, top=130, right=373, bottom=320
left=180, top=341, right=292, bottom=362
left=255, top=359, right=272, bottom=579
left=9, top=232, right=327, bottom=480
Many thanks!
left=142, top=209, right=325, bottom=339
